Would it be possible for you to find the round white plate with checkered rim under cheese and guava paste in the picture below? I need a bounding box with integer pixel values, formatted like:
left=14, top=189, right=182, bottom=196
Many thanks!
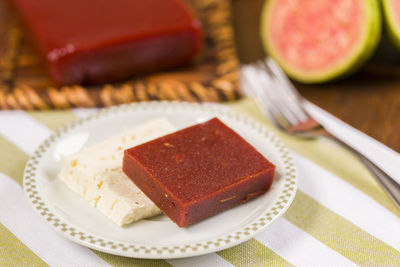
left=24, top=102, right=297, bottom=259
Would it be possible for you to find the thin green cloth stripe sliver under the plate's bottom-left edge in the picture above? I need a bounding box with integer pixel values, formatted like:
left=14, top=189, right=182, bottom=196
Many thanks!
left=93, top=250, right=171, bottom=267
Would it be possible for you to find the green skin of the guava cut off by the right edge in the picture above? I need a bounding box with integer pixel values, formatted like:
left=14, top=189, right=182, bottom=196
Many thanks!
left=381, top=0, right=400, bottom=50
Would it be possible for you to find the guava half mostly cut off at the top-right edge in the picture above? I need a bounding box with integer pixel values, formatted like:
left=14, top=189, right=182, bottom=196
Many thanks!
left=382, top=0, right=400, bottom=49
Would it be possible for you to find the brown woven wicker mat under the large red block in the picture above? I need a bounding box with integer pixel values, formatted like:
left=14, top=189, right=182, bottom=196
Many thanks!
left=0, top=0, right=240, bottom=110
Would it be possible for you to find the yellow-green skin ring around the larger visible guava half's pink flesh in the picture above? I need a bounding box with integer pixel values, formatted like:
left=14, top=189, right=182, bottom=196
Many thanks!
left=260, top=0, right=382, bottom=84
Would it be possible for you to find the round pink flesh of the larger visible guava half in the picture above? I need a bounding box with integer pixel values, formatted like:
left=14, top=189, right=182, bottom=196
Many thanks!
left=269, top=0, right=365, bottom=72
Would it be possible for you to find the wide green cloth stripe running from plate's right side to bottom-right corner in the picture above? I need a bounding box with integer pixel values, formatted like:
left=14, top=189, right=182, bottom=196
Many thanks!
left=284, top=190, right=400, bottom=266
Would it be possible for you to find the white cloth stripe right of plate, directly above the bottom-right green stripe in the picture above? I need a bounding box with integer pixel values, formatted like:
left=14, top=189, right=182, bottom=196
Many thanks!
left=293, top=153, right=400, bottom=251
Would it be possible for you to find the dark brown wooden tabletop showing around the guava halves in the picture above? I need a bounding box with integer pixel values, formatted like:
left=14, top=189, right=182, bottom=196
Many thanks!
left=233, top=0, right=400, bottom=152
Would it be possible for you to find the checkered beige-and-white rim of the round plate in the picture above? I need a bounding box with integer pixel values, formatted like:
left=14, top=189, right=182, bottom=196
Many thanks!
left=23, top=101, right=297, bottom=259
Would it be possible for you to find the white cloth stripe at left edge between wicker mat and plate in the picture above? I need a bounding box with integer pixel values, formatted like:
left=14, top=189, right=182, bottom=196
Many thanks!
left=0, top=111, right=52, bottom=155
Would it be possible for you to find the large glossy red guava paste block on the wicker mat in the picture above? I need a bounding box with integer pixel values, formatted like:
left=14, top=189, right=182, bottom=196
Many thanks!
left=10, top=0, right=202, bottom=85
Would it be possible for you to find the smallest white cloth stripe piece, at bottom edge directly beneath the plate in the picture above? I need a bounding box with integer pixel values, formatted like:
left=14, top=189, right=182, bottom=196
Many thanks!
left=166, top=253, right=233, bottom=267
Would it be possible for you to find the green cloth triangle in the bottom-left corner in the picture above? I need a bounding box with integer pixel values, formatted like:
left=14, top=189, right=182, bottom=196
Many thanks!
left=0, top=224, right=48, bottom=266
